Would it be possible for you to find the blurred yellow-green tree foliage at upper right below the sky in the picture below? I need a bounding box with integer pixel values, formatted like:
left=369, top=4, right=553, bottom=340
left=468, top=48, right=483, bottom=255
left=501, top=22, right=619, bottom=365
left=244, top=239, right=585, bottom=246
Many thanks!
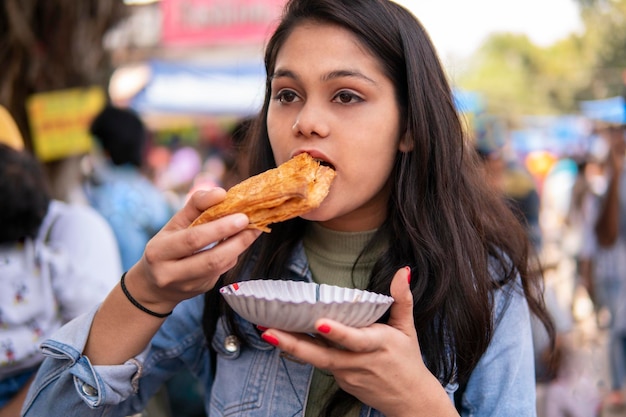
left=455, top=0, right=626, bottom=119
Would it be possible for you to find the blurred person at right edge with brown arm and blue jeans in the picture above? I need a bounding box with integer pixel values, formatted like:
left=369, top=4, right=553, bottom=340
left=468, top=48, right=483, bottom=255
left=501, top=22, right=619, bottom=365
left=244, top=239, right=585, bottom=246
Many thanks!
left=593, top=120, right=626, bottom=410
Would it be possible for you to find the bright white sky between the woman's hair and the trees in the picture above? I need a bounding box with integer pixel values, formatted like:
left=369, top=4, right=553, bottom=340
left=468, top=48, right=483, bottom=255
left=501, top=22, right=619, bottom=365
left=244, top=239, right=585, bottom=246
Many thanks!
left=394, top=0, right=582, bottom=61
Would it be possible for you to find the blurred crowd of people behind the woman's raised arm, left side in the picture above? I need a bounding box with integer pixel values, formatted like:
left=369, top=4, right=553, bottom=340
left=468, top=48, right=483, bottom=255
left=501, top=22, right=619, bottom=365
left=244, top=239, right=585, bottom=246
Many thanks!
left=0, top=105, right=251, bottom=417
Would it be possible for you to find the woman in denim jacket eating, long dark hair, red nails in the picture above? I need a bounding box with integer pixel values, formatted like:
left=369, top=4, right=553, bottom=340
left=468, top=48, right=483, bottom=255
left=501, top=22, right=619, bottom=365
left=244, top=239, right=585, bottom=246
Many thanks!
left=25, top=0, right=551, bottom=417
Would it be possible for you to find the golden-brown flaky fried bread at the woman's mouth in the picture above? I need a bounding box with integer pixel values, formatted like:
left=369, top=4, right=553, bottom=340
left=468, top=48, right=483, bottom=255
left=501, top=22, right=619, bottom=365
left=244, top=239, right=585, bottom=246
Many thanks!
left=191, top=153, right=336, bottom=233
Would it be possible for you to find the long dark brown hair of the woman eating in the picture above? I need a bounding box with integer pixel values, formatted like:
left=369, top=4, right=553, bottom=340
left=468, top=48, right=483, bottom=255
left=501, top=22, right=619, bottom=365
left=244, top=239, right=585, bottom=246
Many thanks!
left=205, top=0, right=553, bottom=415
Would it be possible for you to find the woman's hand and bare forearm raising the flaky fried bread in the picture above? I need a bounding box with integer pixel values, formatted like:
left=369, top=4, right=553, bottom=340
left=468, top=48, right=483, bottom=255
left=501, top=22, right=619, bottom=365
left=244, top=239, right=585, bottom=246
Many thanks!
left=83, top=188, right=261, bottom=365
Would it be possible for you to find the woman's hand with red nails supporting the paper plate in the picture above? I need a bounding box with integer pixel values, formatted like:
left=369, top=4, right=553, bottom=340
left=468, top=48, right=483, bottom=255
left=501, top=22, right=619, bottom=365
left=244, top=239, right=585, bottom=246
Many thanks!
left=256, top=268, right=458, bottom=417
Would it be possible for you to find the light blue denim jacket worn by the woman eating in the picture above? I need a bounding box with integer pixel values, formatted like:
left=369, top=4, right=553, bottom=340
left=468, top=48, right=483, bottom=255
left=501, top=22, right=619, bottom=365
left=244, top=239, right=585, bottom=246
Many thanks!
left=23, top=242, right=536, bottom=417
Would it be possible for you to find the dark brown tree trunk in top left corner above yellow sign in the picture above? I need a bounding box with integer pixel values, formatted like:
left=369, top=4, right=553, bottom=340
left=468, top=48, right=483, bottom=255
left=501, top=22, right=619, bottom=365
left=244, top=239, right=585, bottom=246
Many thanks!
left=0, top=0, right=127, bottom=150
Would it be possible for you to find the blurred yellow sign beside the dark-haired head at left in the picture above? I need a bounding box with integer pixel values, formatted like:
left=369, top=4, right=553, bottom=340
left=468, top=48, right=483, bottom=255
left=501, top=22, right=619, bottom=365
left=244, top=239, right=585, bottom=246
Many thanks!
left=26, top=87, right=106, bottom=162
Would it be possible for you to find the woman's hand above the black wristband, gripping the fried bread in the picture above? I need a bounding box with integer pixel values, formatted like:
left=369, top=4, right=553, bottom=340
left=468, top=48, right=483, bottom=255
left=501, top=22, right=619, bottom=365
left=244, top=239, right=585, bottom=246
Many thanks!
left=126, top=188, right=261, bottom=318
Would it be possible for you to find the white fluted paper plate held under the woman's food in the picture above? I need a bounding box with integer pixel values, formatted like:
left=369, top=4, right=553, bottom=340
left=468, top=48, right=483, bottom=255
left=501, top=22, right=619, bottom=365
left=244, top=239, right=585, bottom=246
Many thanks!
left=220, top=280, right=393, bottom=333
